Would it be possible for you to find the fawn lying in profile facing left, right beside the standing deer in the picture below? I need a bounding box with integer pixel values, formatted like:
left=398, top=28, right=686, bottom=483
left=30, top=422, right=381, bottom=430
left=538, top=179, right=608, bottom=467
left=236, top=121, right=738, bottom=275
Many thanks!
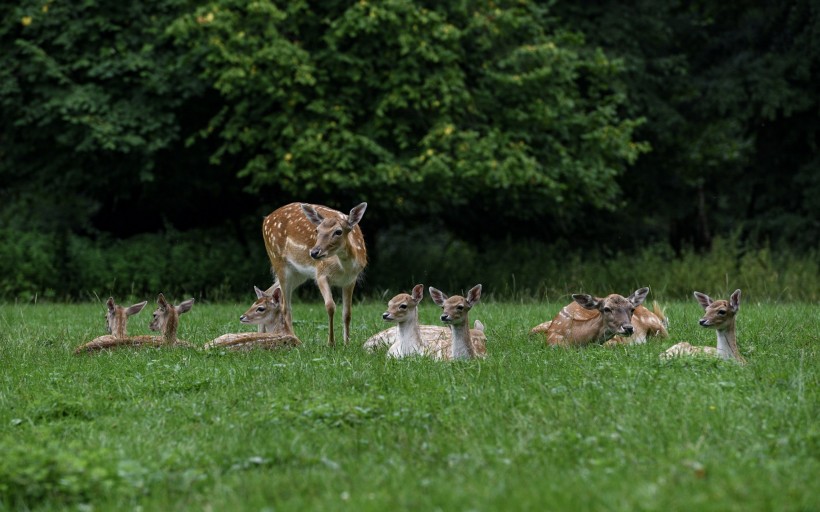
left=203, top=286, right=302, bottom=350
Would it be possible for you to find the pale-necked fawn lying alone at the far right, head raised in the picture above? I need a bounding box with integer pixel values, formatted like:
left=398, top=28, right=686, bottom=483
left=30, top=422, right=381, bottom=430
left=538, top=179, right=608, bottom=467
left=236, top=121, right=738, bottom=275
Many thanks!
left=661, top=290, right=746, bottom=364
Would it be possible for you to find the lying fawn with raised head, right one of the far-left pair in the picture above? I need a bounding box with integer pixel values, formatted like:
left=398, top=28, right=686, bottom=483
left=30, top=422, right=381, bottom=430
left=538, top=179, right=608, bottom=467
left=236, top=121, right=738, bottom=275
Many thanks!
left=74, top=293, right=194, bottom=354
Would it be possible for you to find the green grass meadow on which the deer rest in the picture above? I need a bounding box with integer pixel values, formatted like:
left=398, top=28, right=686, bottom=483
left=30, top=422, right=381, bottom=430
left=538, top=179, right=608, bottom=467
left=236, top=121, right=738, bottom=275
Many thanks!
left=0, top=296, right=820, bottom=511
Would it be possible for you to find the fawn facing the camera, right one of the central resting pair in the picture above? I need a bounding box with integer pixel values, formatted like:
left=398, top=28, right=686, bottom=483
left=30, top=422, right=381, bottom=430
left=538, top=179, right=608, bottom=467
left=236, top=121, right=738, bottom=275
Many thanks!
left=430, top=284, right=487, bottom=359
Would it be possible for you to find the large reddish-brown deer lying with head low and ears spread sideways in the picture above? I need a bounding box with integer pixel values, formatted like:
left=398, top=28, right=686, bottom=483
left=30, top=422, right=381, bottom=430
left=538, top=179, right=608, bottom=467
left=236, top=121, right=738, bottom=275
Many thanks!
left=531, top=288, right=668, bottom=346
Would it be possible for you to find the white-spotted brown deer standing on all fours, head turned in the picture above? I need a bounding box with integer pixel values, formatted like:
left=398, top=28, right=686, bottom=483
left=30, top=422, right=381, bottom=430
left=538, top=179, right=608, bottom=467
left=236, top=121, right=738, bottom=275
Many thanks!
left=262, top=203, right=367, bottom=345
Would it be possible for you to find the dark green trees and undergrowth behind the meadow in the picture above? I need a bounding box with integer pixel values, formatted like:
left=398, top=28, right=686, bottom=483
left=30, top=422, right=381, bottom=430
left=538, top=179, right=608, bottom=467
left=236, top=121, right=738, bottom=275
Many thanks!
left=0, top=0, right=820, bottom=300
